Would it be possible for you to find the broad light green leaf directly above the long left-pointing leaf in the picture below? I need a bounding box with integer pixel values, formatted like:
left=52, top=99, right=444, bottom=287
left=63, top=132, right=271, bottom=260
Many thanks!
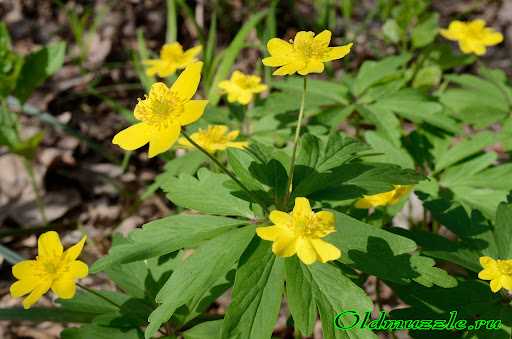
left=162, top=168, right=254, bottom=219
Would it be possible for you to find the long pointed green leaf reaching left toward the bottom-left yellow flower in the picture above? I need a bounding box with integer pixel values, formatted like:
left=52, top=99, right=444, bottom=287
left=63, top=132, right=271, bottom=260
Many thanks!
left=91, top=215, right=246, bottom=273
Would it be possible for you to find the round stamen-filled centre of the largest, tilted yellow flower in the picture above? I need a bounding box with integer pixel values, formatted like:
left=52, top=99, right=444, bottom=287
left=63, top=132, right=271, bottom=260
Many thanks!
left=135, top=91, right=185, bottom=129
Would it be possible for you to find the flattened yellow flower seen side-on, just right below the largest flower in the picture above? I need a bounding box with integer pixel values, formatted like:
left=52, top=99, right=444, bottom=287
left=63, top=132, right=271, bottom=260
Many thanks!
left=178, top=125, right=247, bottom=154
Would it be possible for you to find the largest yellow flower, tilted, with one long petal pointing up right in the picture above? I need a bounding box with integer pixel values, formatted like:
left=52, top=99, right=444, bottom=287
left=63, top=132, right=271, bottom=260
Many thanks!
left=112, top=62, right=208, bottom=158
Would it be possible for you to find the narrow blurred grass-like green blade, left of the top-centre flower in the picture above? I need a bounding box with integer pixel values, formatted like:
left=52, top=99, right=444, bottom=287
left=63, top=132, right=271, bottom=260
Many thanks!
left=208, top=11, right=267, bottom=106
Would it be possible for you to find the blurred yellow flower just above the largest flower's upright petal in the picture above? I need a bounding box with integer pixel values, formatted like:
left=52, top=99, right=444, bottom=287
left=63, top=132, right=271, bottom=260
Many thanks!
left=142, top=42, right=202, bottom=78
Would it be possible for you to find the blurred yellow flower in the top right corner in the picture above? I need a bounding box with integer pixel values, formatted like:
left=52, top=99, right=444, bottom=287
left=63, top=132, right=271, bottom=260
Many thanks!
left=441, top=19, right=503, bottom=55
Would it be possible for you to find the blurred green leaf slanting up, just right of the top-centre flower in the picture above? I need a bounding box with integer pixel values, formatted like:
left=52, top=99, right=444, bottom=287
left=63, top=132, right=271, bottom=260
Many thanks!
left=352, top=54, right=411, bottom=96
